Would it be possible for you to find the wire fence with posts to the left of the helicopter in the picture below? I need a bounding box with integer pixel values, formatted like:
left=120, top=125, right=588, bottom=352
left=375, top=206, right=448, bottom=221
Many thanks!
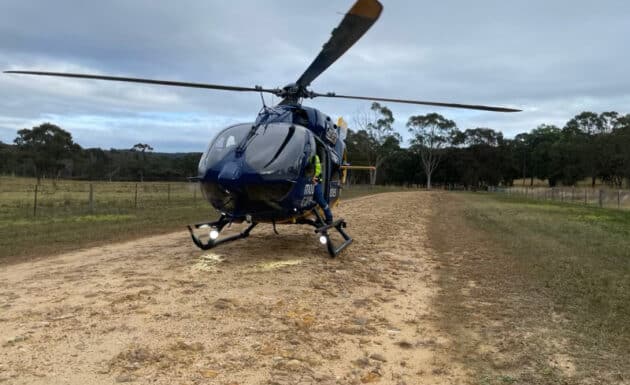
left=0, top=181, right=204, bottom=218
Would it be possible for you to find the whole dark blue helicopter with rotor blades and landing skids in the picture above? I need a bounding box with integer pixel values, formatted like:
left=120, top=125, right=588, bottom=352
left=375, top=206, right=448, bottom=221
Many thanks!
left=5, top=0, right=520, bottom=257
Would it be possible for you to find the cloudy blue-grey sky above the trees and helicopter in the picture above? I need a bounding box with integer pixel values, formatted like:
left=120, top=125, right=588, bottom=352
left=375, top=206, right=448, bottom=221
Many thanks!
left=0, top=0, right=630, bottom=152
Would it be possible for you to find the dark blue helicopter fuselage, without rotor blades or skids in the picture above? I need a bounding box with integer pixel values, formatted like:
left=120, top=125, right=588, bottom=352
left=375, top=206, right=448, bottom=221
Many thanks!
left=198, top=104, right=345, bottom=223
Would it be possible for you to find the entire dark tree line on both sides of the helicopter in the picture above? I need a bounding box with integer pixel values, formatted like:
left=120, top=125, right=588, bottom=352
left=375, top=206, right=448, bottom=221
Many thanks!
left=0, top=108, right=630, bottom=189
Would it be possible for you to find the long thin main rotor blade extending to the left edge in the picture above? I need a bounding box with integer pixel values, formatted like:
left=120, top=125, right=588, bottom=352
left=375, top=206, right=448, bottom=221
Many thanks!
left=4, top=71, right=280, bottom=94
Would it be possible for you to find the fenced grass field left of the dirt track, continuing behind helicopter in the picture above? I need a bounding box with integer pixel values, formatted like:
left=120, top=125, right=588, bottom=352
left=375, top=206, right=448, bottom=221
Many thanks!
left=0, top=177, right=410, bottom=263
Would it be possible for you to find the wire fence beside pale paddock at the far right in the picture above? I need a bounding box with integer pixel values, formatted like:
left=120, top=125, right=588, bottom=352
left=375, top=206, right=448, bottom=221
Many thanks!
left=490, top=187, right=630, bottom=210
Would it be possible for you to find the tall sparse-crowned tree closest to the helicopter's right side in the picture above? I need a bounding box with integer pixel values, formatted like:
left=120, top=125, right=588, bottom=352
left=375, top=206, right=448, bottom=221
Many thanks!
left=353, top=102, right=402, bottom=183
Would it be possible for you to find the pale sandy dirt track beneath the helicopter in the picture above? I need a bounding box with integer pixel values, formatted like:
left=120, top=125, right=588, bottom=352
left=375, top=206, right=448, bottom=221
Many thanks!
left=0, top=192, right=464, bottom=385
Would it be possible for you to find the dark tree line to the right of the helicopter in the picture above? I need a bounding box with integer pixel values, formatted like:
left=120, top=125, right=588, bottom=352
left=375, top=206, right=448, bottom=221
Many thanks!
left=346, top=103, right=630, bottom=188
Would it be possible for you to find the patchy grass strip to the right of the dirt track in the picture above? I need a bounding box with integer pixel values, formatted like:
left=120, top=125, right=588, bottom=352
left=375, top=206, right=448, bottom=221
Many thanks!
left=432, top=193, right=630, bottom=384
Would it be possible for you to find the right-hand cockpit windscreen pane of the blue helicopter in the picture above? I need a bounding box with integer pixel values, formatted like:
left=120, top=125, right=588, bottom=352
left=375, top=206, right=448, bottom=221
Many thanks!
left=245, top=123, right=308, bottom=180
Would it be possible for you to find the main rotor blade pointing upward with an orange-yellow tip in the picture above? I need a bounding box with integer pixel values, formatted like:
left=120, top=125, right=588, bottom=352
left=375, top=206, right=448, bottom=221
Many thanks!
left=296, top=0, right=383, bottom=87
